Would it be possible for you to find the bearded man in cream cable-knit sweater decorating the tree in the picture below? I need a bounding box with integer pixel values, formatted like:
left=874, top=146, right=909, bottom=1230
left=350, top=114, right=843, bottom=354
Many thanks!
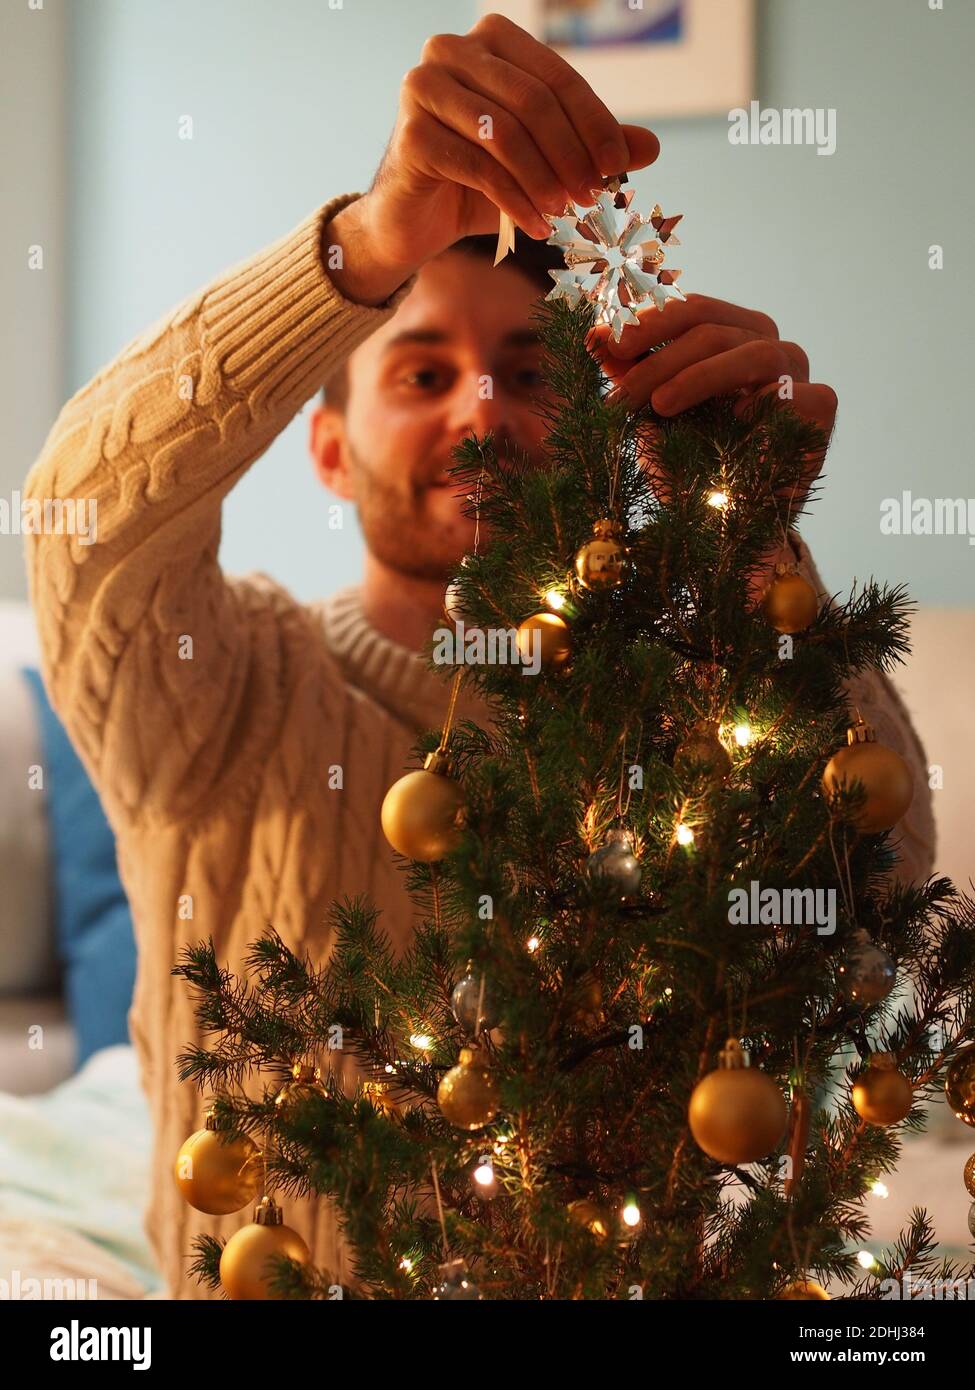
left=26, top=17, right=932, bottom=1298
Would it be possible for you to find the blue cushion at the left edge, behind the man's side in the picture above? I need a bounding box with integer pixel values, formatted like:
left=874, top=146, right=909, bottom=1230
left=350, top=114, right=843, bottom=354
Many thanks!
left=24, top=669, right=135, bottom=1066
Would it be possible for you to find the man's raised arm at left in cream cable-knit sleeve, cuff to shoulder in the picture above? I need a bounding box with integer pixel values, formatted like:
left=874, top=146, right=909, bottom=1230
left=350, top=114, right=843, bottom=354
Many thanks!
left=24, top=195, right=411, bottom=819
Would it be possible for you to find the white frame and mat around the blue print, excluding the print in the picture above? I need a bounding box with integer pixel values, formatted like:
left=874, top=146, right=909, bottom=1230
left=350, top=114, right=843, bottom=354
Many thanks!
left=481, top=0, right=755, bottom=122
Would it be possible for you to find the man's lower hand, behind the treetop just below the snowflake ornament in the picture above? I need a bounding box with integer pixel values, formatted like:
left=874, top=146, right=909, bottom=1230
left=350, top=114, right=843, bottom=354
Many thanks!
left=593, top=295, right=836, bottom=482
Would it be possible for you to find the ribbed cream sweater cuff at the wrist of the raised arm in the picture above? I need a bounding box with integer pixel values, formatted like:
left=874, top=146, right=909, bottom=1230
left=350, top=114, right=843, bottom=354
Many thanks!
left=202, top=193, right=413, bottom=413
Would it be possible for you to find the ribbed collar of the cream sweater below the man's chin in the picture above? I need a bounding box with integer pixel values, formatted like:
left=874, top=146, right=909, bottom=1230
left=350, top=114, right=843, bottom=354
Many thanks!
left=313, top=585, right=490, bottom=734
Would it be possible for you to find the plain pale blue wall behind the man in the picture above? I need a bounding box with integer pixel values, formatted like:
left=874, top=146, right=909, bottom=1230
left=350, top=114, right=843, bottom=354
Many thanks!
left=65, top=0, right=975, bottom=603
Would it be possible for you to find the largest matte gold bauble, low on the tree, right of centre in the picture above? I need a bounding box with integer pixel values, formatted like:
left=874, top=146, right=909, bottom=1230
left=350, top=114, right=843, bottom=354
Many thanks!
left=687, top=1038, right=789, bottom=1163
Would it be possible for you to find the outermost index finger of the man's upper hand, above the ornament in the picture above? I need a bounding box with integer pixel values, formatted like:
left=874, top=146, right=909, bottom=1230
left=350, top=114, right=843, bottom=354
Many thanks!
left=470, top=14, right=655, bottom=177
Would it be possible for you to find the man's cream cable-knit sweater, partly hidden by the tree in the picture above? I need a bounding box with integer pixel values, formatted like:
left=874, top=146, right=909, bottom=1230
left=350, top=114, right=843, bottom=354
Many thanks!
left=25, top=195, right=933, bottom=1298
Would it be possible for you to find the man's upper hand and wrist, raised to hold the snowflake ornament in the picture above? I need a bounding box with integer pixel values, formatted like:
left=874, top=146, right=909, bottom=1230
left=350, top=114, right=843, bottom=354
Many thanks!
left=323, top=14, right=659, bottom=303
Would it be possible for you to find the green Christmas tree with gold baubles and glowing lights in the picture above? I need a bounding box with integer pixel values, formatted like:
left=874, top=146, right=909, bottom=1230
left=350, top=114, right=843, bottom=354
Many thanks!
left=177, top=290, right=975, bottom=1300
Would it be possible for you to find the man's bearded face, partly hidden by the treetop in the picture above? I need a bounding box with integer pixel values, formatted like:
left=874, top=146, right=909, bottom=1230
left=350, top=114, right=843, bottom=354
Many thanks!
left=312, top=252, right=545, bottom=581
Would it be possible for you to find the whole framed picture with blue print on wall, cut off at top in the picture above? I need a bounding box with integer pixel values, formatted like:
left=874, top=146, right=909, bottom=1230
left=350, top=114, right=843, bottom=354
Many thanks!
left=481, top=0, right=755, bottom=120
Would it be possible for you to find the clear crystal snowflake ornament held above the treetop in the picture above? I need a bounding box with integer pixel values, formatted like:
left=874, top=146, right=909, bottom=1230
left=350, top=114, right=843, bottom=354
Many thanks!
left=547, top=175, right=684, bottom=342
